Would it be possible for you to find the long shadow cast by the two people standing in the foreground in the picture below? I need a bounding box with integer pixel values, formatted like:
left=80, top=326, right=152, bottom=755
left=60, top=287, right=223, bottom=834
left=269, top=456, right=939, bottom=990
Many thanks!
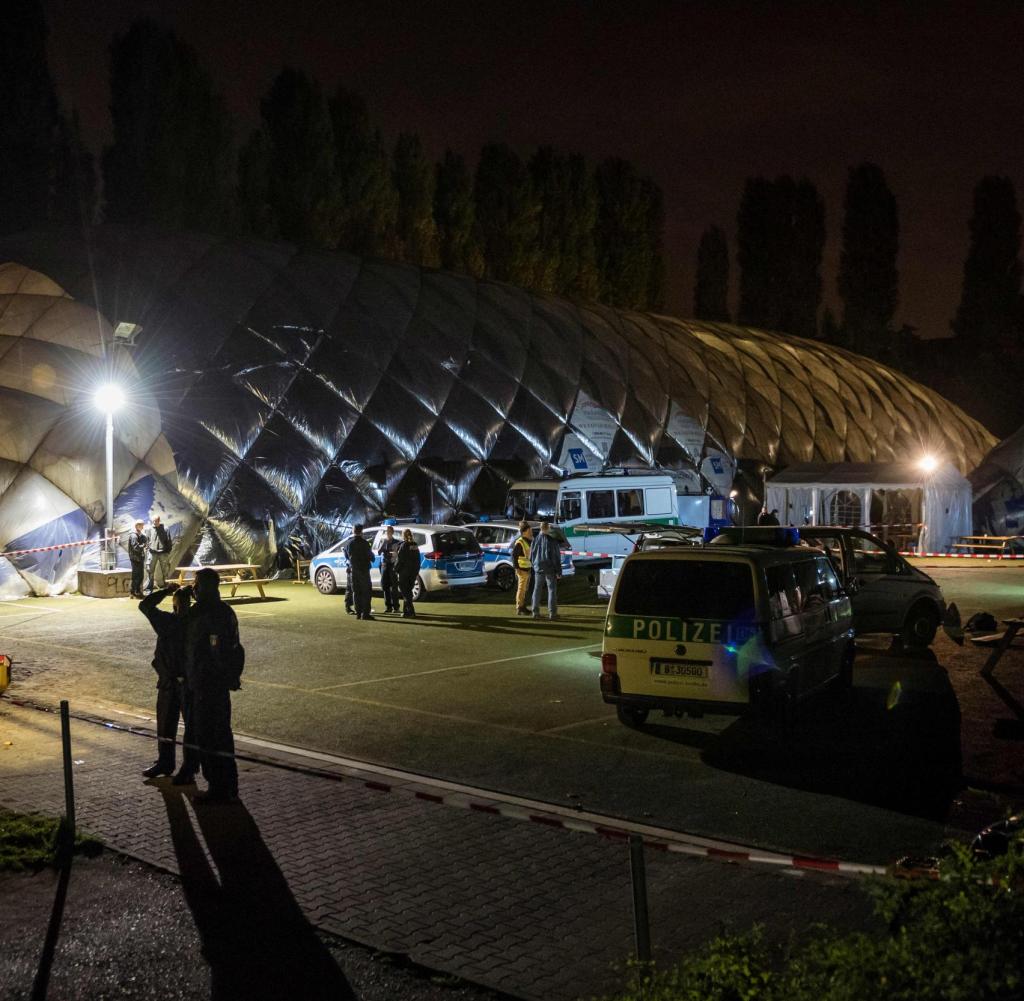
left=160, top=783, right=355, bottom=1001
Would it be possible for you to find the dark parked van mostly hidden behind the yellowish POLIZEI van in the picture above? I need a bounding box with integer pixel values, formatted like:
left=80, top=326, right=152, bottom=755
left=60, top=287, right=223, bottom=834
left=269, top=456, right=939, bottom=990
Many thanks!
left=710, top=525, right=946, bottom=648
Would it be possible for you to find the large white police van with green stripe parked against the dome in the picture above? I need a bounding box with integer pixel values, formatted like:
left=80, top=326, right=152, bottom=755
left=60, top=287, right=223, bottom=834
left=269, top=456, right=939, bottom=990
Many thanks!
left=505, top=469, right=679, bottom=554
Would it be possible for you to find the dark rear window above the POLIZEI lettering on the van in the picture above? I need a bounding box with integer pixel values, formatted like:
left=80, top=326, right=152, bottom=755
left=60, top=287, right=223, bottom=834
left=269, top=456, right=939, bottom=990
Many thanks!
left=615, top=560, right=755, bottom=622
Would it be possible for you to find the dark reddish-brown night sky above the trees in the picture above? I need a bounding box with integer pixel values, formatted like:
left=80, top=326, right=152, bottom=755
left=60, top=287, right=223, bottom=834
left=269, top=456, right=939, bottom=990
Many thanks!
left=45, top=0, right=1024, bottom=337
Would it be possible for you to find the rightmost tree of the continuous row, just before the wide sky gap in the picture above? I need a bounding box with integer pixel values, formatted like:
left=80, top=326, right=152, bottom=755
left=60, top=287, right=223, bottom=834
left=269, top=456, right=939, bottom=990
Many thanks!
left=595, top=158, right=665, bottom=309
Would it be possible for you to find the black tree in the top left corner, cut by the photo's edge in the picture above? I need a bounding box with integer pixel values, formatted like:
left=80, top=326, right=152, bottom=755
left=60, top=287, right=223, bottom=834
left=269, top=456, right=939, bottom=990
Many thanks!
left=0, top=0, right=58, bottom=232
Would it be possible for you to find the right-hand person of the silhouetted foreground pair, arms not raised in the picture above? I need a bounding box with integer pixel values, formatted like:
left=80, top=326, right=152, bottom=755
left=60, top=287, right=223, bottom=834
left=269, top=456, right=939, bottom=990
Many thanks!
left=185, top=567, right=245, bottom=802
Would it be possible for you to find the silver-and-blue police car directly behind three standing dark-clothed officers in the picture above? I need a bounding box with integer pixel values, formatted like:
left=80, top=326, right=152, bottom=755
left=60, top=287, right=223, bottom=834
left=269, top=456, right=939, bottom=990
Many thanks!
left=309, top=522, right=487, bottom=601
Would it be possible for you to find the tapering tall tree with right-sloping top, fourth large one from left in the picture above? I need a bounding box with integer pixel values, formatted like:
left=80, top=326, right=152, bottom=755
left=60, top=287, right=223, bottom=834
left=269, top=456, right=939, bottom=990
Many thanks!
left=330, top=87, right=400, bottom=258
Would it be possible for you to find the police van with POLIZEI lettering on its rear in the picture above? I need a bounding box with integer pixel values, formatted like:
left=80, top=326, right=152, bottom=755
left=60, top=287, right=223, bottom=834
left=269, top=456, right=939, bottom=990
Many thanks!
left=601, top=546, right=854, bottom=727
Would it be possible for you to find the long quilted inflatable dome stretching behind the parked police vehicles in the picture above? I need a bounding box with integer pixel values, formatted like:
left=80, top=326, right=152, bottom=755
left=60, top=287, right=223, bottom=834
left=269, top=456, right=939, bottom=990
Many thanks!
left=0, top=226, right=994, bottom=559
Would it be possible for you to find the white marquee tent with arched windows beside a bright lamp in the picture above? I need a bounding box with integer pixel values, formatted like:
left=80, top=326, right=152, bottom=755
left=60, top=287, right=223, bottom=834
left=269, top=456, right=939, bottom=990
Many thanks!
left=765, top=463, right=971, bottom=553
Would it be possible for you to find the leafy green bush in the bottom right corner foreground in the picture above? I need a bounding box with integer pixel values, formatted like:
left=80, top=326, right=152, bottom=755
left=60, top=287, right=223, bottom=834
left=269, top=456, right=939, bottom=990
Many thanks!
left=602, top=843, right=1024, bottom=1001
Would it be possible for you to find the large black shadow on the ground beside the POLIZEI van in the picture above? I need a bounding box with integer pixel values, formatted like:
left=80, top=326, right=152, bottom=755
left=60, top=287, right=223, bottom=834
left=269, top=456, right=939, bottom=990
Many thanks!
left=644, top=650, right=964, bottom=820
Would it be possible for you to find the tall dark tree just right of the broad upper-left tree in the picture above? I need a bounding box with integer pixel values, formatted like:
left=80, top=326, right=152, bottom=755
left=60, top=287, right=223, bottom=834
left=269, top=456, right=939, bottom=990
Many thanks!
left=256, top=69, right=340, bottom=249
